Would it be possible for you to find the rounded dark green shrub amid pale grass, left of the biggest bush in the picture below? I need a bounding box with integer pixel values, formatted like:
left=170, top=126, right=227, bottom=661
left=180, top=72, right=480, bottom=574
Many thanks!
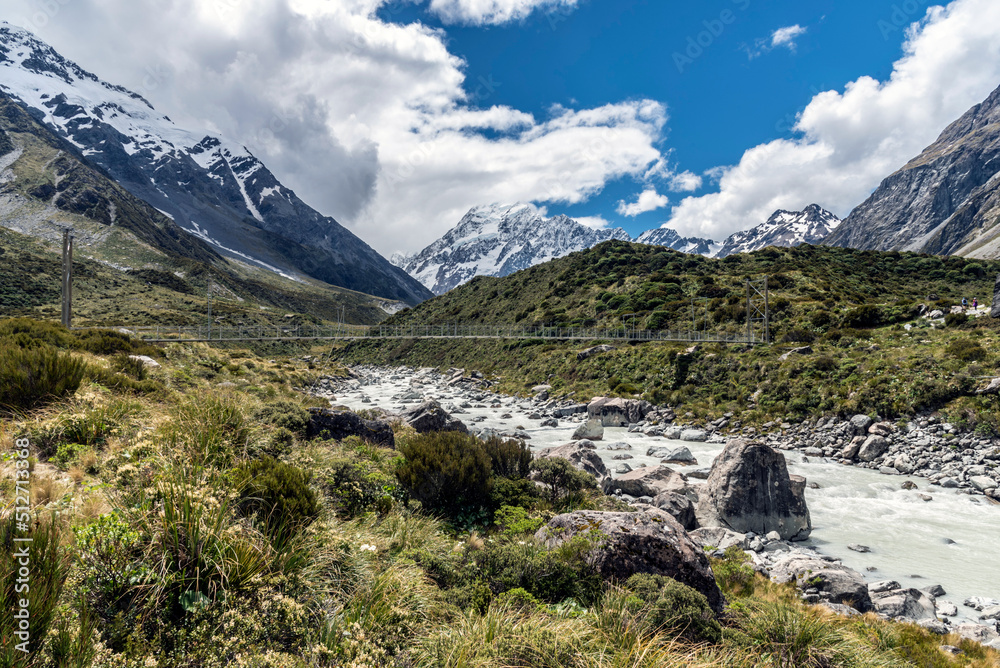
left=233, top=457, right=319, bottom=535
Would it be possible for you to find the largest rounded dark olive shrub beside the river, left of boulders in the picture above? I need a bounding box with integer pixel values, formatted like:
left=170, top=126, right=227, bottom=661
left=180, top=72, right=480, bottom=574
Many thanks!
left=396, top=431, right=492, bottom=517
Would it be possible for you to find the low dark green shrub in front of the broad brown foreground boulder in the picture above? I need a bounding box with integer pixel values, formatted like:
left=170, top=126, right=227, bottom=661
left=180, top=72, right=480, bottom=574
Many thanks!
left=625, top=574, right=722, bottom=643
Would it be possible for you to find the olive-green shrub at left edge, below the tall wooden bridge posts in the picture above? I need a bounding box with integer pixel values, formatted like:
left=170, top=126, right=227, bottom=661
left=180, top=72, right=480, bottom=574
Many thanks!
left=0, top=343, right=86, bottom=410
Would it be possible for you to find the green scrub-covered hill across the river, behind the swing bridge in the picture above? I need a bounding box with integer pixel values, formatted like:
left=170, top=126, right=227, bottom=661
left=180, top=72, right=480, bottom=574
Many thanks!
left=334, top=241, right=1000, bottom=433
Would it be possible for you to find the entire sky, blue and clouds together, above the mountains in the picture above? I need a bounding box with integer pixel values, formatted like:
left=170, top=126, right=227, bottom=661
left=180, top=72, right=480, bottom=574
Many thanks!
left=13, top=0, right=1000, bottom=256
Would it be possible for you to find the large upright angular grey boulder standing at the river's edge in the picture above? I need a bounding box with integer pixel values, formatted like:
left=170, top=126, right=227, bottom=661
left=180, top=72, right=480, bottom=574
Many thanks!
left=697, top=439, right=812, bottom=540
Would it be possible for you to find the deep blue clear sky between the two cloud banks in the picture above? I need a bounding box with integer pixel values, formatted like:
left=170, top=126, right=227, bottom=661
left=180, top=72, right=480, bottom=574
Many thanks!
left=380, top=0, right=928, bottom=236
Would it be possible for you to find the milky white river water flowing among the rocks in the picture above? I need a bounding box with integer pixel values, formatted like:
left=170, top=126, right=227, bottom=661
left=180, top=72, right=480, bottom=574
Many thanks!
left=333, top=370, right=1000, bottom=616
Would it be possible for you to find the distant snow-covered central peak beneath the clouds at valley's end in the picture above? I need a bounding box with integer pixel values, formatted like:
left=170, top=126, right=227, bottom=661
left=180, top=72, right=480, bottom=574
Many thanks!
left=393, top=204, right=631, bottom=295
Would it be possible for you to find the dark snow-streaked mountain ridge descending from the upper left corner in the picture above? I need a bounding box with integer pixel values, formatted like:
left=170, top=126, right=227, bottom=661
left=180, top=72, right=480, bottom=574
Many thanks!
left=0, top=22, right=431, bottom=304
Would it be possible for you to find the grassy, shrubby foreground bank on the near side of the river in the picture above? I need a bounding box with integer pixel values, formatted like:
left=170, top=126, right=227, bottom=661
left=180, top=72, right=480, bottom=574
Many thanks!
left=0, top=320, right=1000, bottom=668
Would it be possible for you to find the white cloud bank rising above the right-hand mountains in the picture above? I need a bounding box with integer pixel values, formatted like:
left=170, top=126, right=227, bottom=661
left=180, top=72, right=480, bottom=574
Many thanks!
left=670, top=0, right=1000, bottom=239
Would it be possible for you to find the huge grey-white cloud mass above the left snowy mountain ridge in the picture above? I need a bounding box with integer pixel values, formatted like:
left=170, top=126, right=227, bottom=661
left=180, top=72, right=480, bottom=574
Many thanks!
left=5, top=0, right=667, bottom=254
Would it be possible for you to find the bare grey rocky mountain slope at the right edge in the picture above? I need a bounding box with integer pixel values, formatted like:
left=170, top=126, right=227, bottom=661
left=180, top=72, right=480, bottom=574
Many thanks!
left=825, top=81, right=1000, bottom=258
